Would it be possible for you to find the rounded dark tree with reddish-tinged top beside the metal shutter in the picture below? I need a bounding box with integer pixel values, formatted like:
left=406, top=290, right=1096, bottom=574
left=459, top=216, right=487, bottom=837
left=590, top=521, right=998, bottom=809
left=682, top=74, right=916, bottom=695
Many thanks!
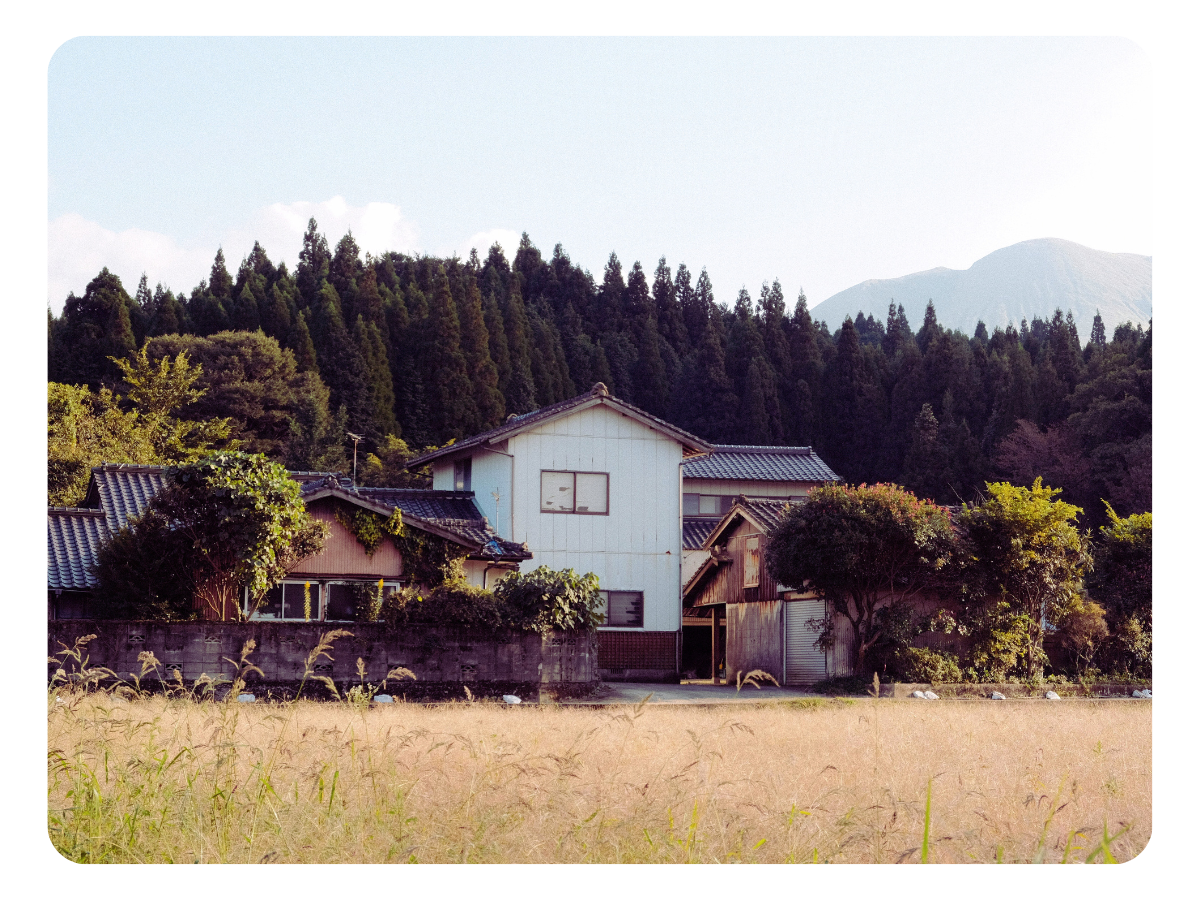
left=766, top=485, right=953, bottom=674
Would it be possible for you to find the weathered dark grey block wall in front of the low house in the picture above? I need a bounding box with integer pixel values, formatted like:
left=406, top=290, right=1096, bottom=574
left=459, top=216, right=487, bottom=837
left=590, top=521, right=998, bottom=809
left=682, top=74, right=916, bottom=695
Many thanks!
left=46, top=619, right=600, bottom=698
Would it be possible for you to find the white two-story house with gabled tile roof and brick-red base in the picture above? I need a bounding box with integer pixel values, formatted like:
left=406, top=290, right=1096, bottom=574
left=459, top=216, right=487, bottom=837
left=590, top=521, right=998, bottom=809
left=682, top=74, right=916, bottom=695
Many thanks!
left=409, top=384, right=712, bottom=680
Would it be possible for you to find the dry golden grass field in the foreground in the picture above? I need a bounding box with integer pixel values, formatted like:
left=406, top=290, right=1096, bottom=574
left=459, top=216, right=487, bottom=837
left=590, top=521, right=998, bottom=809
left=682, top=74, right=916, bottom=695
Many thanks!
left=46, top=692, right=1153, bottom=864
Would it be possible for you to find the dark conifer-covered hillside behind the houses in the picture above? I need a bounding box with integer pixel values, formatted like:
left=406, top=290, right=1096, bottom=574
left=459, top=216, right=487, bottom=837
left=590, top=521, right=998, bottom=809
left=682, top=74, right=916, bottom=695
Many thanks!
left=47, top=222, right=1153, bottom=527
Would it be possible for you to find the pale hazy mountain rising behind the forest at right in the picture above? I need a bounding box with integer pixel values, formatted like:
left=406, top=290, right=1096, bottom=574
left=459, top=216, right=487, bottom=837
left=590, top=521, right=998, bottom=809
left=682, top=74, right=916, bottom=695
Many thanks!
left=812, top=238, right=1154, bottom=343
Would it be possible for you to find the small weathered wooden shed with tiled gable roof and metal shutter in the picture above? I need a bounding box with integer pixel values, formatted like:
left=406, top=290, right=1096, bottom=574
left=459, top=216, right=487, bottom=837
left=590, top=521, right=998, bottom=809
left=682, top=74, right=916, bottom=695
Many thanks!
left=683, top=497, right=852, bottom=684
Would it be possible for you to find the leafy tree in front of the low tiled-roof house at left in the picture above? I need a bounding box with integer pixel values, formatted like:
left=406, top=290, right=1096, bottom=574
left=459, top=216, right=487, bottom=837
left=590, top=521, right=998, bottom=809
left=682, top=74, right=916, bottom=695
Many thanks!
left=149, top=452, right=329, bottom=620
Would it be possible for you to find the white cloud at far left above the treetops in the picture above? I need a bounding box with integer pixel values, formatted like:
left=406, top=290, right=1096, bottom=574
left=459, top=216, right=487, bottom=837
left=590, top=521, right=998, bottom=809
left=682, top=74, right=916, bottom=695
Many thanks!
left=46, top=212, right=216, bottom=314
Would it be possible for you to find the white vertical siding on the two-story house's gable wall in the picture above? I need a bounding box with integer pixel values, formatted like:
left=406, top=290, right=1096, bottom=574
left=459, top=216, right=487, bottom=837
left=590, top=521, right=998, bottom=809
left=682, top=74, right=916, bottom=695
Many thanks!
left=511, top=407, right=683, bottom=631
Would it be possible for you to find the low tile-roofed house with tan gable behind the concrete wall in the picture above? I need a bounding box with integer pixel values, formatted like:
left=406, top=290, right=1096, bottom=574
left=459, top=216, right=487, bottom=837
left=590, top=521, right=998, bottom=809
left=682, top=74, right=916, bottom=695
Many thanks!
left=46, top=463, right=532, bottom=622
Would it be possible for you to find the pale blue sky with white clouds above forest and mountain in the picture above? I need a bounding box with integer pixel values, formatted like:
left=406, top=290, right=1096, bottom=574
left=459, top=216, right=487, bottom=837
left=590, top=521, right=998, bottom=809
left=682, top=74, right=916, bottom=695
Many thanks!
left=46, top=37, right=1153, bottom=314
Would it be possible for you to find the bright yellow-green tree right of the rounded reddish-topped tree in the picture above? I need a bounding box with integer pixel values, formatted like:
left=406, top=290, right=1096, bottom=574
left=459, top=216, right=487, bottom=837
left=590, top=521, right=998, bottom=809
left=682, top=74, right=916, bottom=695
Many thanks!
left=959, top=478, right=1092, bottom=678
